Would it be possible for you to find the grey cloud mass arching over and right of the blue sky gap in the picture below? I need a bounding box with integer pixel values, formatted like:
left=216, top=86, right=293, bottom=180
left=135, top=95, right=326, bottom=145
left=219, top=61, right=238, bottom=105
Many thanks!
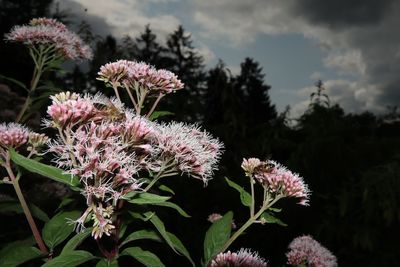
left=194, top=0, right=400, bottom=112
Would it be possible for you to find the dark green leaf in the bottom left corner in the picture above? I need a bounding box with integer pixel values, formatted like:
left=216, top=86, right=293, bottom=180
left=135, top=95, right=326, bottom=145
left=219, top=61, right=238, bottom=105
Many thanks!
left=0, top=238, right=42, bottom=267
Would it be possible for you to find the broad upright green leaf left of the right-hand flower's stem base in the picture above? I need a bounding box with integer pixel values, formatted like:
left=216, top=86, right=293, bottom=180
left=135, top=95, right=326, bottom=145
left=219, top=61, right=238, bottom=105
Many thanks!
left=204, top=211, right=233, bottom=266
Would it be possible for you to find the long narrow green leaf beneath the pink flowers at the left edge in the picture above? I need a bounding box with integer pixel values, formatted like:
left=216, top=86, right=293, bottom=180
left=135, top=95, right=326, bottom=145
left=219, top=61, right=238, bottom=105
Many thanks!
left=10, top=149, right=80, bottom=187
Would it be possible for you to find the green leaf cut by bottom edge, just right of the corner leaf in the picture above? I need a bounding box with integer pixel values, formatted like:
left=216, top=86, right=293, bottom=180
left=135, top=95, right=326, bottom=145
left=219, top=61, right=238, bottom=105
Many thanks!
left=42, top=250, right=96, bottom=267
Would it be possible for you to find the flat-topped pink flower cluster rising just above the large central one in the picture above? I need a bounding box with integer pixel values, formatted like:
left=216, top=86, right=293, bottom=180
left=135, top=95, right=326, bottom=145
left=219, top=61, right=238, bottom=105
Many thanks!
left=98, top=60, right=183, bottom=94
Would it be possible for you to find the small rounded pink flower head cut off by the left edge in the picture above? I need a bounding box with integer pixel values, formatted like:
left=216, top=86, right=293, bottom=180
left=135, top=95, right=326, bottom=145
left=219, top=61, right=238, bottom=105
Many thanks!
left=0, top=123, right=29, bottom=148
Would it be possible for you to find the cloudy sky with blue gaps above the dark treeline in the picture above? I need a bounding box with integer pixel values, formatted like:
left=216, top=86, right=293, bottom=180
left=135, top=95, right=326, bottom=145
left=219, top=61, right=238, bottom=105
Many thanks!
left=56, top=0, right=400, bottom=114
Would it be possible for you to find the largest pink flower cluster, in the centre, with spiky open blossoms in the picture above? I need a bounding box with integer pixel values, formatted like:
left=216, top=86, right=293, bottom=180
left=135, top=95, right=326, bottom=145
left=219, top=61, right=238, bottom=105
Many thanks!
left=45, top=92, right=222, bottom=239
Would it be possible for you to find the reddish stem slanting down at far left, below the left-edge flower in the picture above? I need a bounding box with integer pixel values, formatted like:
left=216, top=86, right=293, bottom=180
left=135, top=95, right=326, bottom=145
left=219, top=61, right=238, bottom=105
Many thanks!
left=5, top=152, right=49, bottom=254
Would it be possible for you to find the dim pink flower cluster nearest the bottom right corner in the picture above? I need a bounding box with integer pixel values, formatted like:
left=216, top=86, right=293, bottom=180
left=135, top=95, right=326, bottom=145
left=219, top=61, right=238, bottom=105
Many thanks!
left=286, top=236, right=337, bottom=267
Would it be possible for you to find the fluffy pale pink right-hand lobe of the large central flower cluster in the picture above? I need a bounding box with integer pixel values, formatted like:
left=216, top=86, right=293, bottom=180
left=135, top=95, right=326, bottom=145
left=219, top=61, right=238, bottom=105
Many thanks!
left=159, top=122, right=223, bottom=183
